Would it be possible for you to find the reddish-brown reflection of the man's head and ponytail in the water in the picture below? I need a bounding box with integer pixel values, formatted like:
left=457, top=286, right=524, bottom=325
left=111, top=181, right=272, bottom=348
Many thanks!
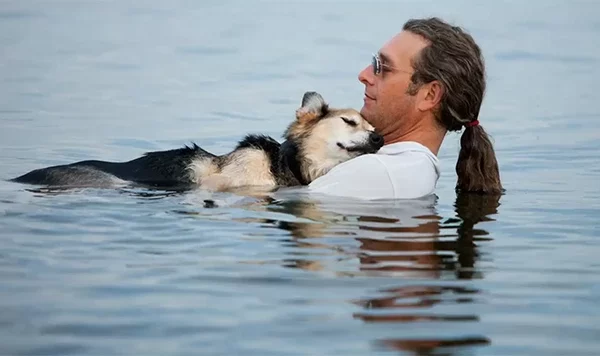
left=355, top=194, right=500, bottom=355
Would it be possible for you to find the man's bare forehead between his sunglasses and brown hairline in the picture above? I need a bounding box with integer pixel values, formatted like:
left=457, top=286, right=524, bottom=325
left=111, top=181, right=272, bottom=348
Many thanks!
left=379, top=31, right=429, bottom=65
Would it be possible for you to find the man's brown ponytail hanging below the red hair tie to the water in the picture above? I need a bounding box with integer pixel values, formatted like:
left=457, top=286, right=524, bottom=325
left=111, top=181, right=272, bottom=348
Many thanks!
left=456, top=124, right=503, bottom=194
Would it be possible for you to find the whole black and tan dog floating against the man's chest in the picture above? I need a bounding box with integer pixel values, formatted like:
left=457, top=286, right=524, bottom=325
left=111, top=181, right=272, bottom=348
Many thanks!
left=13, top=92, right=383, bottom=191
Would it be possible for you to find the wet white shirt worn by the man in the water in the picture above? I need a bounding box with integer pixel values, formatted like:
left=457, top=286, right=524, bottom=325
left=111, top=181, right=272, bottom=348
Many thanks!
left=308, top=141, right=440, bottom=200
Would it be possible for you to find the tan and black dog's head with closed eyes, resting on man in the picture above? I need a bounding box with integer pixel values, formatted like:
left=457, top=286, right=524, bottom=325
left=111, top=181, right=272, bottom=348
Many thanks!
left=285, top=92, right=383, bottom=181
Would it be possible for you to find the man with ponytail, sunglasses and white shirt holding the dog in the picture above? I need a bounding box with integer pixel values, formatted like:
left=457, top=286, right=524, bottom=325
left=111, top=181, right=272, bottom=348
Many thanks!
left=309, top=18, right=502, bottom=199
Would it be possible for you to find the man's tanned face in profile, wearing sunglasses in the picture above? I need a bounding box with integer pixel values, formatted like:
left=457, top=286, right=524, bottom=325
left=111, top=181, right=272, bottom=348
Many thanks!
left=358, top=31, right=428, bottom=143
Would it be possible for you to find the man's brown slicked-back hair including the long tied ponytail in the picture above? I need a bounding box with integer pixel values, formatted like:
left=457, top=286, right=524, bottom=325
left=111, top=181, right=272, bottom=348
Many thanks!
left=403, top=17, right=503, bottom=194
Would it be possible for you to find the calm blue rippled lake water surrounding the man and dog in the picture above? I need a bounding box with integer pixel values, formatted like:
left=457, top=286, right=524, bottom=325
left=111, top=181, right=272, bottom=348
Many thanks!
left=0, top=0, right=600, bottom=356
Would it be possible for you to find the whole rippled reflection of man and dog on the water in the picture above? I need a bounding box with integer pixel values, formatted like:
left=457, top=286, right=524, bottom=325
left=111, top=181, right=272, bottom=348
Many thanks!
left=202, top=194, right=501, bottom=355
